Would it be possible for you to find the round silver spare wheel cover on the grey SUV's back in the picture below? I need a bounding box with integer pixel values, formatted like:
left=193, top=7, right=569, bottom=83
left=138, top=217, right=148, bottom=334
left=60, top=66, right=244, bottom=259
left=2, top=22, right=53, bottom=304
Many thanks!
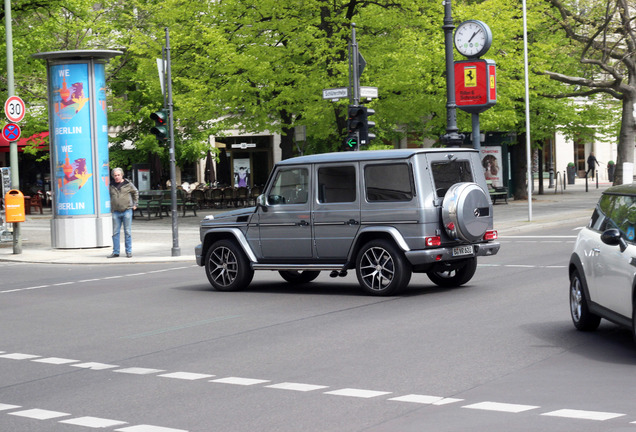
left=442, top=183, right=492, bottom=242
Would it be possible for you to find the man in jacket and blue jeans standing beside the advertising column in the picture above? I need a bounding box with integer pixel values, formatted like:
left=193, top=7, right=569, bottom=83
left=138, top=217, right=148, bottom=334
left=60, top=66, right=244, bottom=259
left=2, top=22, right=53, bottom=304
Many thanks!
left=106, top=168, right=139, bottom=258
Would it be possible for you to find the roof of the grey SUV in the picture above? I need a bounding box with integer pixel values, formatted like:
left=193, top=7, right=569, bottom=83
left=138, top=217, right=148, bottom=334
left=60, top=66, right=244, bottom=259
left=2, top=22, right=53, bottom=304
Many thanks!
left=276, top=147, right=477, bottom=165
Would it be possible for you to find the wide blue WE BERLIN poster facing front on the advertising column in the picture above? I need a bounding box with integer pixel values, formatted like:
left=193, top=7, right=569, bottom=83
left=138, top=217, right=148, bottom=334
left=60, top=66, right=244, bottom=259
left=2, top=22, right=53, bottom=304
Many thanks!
left=50, top=63, right=95, bottom=216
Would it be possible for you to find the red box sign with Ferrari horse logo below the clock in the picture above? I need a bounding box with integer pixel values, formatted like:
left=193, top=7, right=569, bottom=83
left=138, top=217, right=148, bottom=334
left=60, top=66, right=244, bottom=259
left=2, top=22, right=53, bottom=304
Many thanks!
left=455, top=59, right=497, bottom=114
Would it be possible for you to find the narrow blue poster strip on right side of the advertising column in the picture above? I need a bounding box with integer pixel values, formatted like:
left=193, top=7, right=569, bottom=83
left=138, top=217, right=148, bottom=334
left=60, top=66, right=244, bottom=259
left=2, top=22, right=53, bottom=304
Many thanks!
left=95, top=63, right=110, bottom=213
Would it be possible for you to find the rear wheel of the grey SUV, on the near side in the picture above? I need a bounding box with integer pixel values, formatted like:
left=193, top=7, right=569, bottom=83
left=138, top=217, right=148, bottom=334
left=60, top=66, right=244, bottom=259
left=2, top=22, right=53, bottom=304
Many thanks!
left=356, top=239, right=412, bottom=296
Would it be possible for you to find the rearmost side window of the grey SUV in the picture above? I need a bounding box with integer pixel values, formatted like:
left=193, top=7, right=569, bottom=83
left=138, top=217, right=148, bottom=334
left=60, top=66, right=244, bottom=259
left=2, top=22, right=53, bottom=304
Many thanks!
left=364, top=163, right=415, bottom=202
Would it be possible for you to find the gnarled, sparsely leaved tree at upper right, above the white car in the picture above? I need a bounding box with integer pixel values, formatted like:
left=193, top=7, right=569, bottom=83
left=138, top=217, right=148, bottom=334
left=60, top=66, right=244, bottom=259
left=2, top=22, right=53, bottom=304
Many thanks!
left=545, top=0, right=636, bottom=184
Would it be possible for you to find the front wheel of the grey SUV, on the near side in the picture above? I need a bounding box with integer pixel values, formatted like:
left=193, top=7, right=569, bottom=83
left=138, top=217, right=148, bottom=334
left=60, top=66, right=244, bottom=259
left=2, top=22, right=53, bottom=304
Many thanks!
left=205, top=240, right=254, bottom=291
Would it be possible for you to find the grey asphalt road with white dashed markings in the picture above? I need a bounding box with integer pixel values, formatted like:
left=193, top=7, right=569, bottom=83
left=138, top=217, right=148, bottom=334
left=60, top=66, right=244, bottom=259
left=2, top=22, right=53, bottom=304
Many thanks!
left=0, top=222, right=636, bottom=432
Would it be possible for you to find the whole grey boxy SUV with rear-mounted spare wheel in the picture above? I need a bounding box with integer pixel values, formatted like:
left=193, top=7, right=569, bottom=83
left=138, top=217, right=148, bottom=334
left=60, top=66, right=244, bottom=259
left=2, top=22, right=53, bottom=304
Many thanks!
left=195, top=148, right=499, bottom=295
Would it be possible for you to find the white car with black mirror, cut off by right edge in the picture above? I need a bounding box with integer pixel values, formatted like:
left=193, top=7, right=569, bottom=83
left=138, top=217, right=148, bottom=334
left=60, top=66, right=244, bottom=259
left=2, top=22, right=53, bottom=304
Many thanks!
left=569, top=184, right=636, bottom=338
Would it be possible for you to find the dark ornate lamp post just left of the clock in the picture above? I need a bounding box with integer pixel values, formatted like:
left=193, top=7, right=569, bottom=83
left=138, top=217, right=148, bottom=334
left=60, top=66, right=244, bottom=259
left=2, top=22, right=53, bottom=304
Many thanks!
left=442, top=0, right=464, bottom=147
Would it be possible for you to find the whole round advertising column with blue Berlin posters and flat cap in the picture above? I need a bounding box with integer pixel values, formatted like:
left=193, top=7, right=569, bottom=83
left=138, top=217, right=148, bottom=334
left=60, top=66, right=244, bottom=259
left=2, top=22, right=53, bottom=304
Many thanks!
left=34, top=51, right=121, bottom=249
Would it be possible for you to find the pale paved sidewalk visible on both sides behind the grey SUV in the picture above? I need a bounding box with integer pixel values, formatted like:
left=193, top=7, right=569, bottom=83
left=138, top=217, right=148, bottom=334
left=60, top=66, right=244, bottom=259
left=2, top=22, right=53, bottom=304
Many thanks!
left=0, top=179, right=610, bottom=264
